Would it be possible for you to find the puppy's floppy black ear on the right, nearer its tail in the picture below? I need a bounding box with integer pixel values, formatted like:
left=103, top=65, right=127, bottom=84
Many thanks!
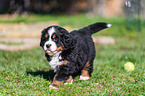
left=58, top=28, right=71, bottom=50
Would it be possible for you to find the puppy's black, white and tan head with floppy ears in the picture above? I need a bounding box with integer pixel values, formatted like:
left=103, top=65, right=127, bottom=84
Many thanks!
left=40, top=26, right=70, bottom=55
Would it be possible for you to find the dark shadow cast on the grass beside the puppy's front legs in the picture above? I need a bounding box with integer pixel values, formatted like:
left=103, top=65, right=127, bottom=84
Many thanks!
left=26, top=70, right=55, bottom=81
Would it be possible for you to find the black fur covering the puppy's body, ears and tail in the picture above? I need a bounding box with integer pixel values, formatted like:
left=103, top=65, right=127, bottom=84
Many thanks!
left=40, top=22, right=108, bottom=81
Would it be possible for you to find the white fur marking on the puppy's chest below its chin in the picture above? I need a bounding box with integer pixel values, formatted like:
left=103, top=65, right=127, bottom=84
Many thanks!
left=49, top=52, right=61, bottom=70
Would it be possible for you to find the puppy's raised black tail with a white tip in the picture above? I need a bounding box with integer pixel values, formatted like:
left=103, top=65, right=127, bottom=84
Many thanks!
left=80, top=22, right=111, bottom=35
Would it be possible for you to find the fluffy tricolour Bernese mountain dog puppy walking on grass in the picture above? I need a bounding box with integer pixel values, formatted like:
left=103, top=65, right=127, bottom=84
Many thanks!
left=40, top=22, right=111, bottom=89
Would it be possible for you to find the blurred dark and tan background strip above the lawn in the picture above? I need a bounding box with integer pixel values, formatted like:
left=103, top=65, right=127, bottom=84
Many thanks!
left=0, top=0, right=125, bottom=16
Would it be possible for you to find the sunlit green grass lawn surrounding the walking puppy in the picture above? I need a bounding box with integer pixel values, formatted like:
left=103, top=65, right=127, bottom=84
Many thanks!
left=0, top=14, right=145, bottom=96
